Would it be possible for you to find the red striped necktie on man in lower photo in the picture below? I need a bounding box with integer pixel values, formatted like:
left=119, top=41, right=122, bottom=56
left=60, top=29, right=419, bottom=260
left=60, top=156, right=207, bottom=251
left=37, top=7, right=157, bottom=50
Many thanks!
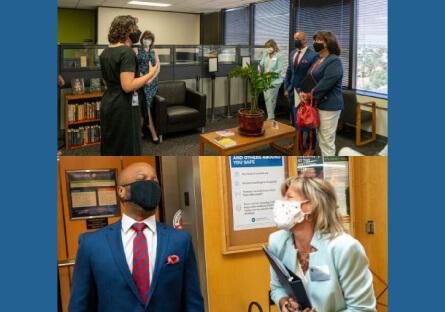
left=133, top=223, right=150, bottom=303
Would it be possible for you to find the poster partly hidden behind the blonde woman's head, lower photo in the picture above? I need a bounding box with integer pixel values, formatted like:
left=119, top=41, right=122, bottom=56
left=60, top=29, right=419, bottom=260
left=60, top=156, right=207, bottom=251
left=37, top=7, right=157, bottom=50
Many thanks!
left=297, top=156, right=350, bottom=216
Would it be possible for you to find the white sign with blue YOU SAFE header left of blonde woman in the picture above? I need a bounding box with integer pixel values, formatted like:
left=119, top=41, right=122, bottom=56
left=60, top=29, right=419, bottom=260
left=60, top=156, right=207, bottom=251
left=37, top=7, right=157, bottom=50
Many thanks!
left=230, top=156, right=286, bottom=231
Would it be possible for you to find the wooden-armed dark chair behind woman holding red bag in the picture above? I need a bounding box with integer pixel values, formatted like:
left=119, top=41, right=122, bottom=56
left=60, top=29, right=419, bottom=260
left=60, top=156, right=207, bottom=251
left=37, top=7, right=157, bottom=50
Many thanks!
left=340, top=90, right=377, bottom=146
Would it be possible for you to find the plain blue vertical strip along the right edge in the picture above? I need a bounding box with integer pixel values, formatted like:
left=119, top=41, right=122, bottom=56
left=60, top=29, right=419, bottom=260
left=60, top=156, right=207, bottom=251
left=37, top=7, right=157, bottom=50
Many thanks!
left=388, top=0, right=445, bottom=311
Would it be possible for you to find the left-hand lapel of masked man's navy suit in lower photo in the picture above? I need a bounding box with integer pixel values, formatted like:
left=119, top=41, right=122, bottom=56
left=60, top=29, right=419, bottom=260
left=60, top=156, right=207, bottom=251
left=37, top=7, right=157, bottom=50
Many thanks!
left=107, top=221, right=144, bottom=304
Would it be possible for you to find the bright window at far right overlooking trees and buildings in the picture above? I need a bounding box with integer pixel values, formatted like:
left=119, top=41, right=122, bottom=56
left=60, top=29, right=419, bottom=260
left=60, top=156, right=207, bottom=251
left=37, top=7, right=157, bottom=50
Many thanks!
left=355, top=0, right=388, bottom=94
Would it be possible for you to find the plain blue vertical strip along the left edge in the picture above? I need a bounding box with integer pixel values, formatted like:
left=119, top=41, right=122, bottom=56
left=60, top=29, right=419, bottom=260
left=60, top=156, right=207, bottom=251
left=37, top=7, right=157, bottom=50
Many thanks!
left=0, top=0, right=57, bottom=311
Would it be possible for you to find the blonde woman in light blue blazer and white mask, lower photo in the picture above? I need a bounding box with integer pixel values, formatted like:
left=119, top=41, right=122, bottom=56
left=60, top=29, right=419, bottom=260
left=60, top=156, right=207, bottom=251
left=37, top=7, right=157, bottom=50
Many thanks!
left=269, top=177, right=376, bottom=312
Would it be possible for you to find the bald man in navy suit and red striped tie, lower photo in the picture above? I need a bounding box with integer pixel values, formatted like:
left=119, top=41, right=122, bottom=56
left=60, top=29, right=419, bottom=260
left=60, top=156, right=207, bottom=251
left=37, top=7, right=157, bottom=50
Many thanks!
left=69, top=163, right=204, bottom=312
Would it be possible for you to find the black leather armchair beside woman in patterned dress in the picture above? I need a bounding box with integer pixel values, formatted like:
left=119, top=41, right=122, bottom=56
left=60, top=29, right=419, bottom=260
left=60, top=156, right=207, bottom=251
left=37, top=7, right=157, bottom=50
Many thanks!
left=153, top=81, right=206, bottom=141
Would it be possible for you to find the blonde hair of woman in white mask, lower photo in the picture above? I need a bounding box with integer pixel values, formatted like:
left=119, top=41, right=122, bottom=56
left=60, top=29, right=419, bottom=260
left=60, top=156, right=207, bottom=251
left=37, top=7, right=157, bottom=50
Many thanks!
left=281, top=177, right=345, bottom=239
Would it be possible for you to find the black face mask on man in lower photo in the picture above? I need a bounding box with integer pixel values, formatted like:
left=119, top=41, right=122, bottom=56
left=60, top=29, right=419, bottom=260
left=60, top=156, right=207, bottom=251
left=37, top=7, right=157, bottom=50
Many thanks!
left=124, top=180, right=161, bottom=211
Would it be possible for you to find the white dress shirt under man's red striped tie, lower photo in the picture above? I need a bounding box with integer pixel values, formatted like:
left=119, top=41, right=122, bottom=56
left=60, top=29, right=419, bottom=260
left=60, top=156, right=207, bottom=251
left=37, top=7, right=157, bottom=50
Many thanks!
left=121, top=214, right=157, bottom=283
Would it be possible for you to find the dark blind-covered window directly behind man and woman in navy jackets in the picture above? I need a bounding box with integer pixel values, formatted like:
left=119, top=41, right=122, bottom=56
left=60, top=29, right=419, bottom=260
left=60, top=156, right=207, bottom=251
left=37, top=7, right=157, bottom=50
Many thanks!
left=295, top=0, right=352, bottom=87
